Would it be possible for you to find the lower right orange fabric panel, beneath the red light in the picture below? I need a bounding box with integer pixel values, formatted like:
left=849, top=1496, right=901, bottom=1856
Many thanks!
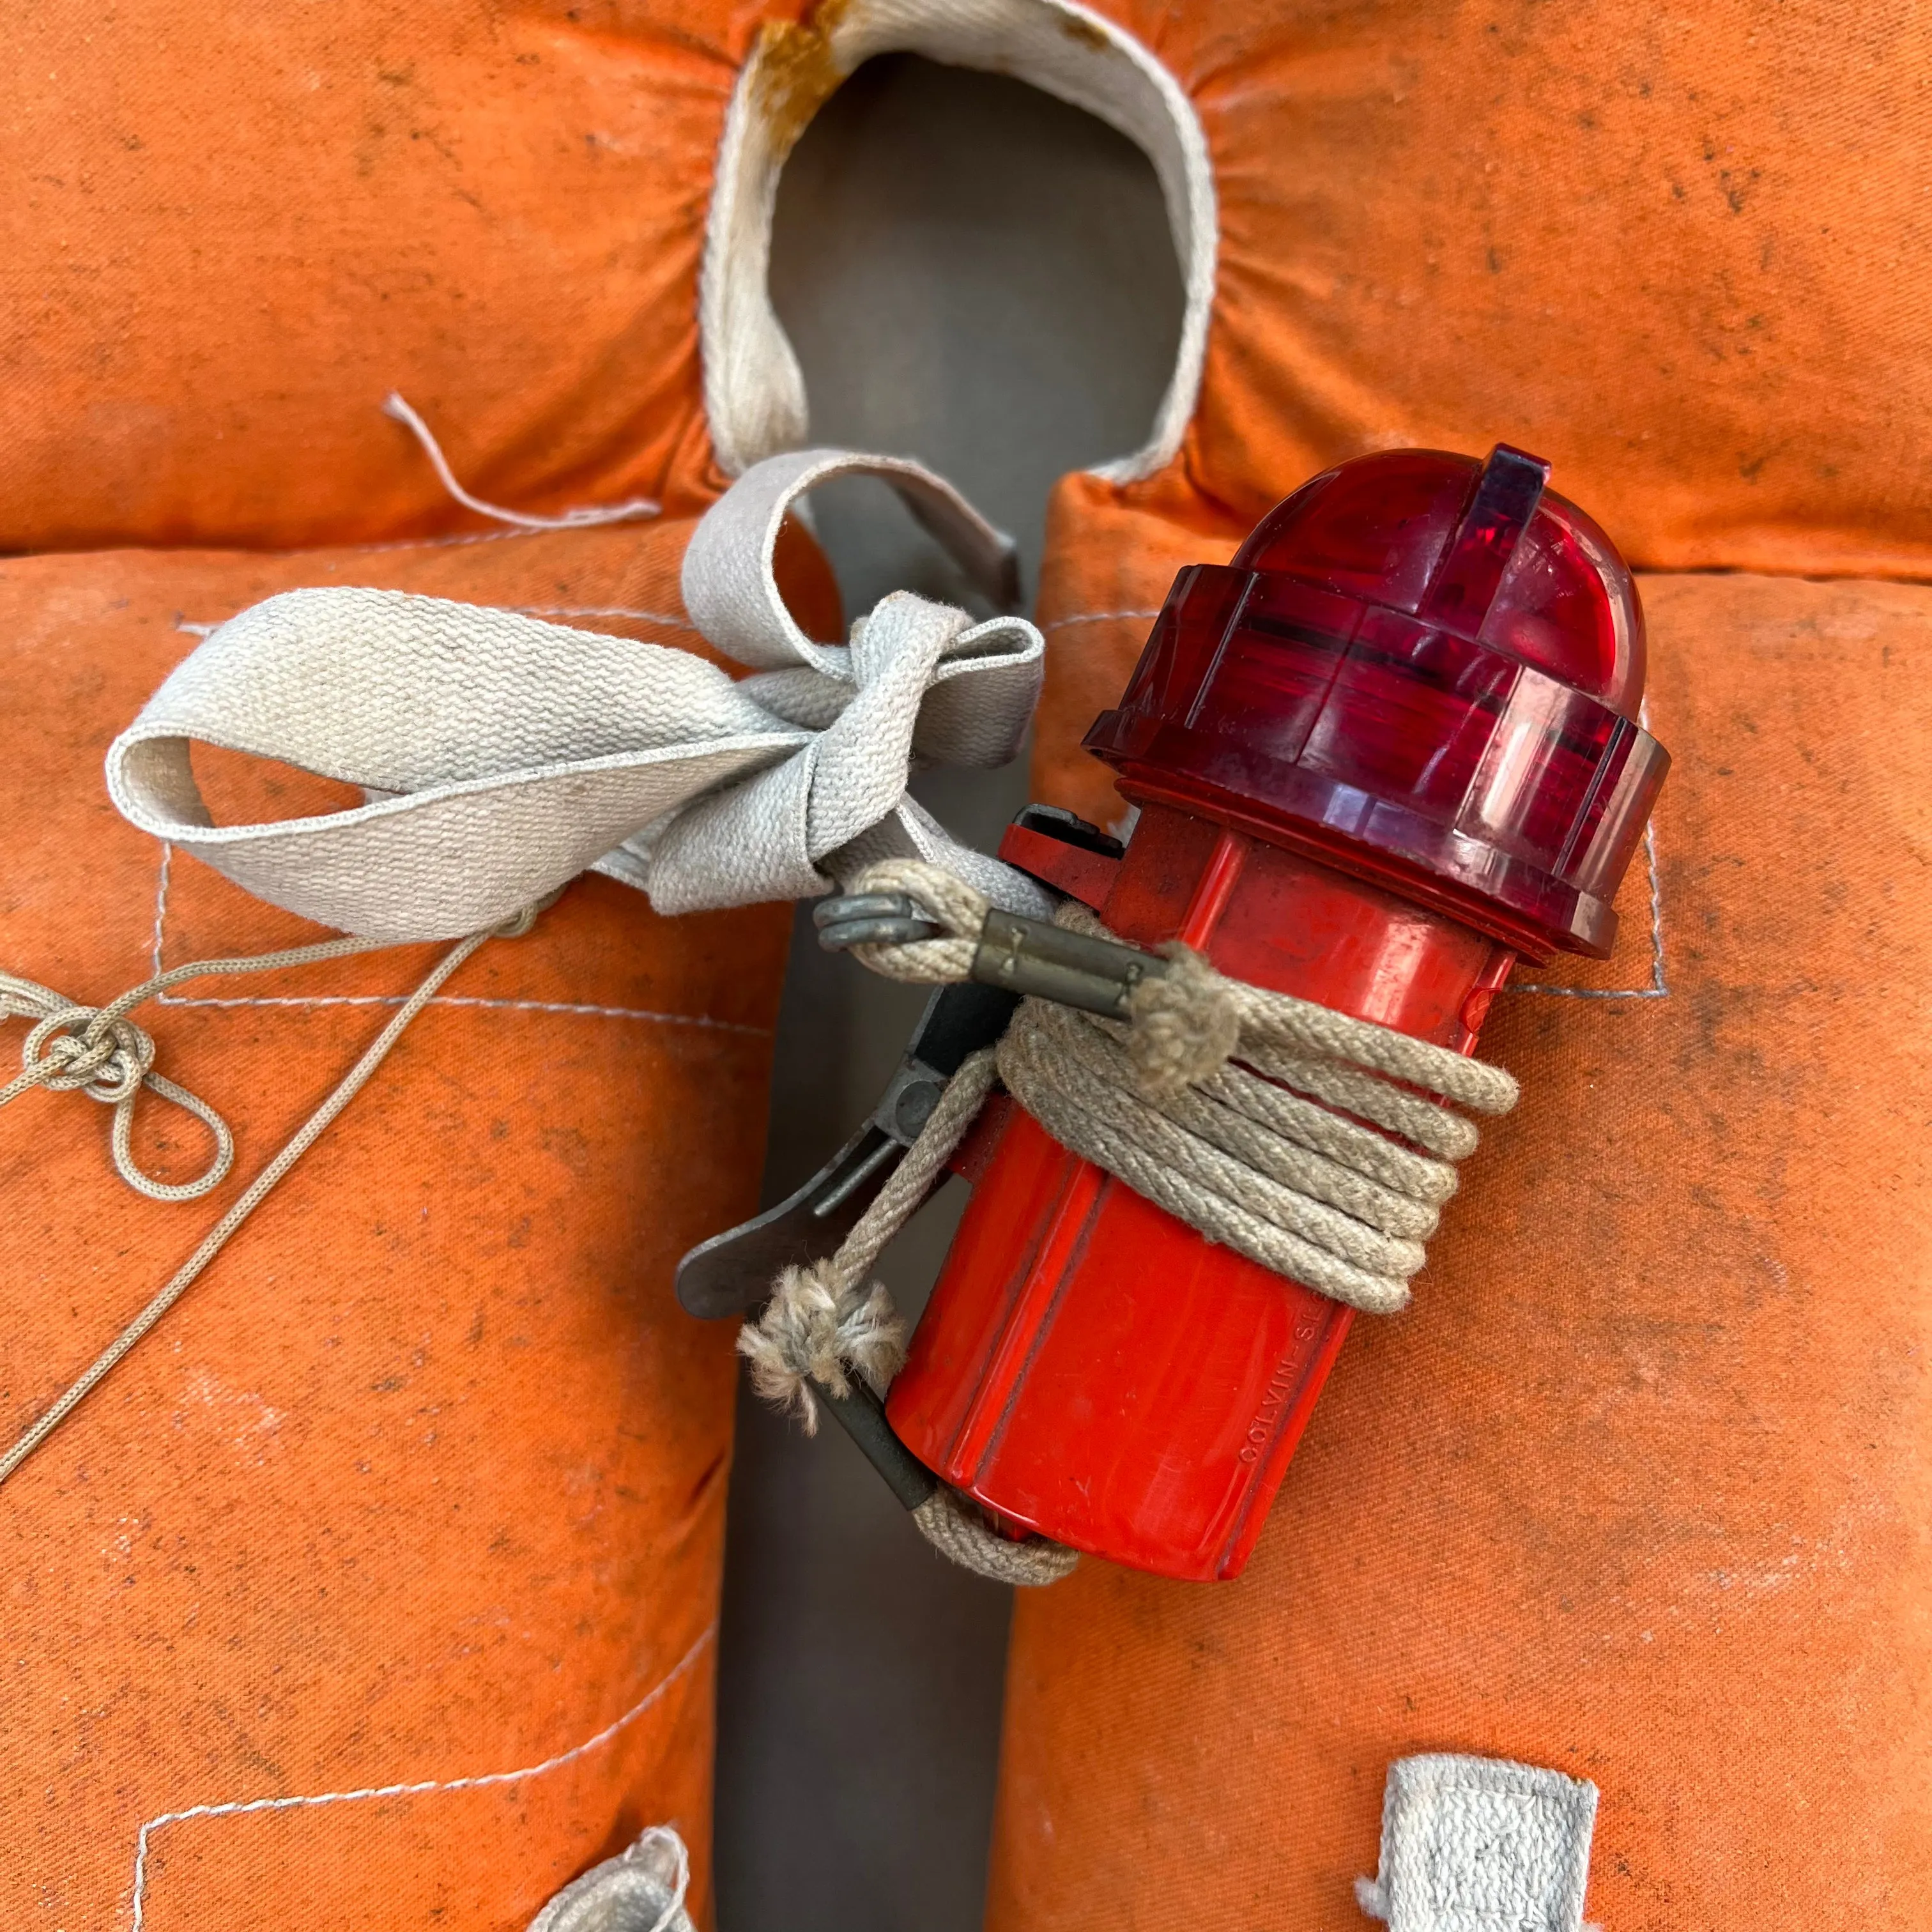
left=991, top=576, right=1932, bottom=1932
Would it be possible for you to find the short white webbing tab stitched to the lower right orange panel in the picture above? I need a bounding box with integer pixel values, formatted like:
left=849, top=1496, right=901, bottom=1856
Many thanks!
left=1354, top=1754, right=1596, bottom=1932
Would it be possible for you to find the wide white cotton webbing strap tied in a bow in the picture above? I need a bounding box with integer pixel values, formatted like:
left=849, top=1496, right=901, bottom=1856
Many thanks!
left=106, top=450, right=1045, bottom=941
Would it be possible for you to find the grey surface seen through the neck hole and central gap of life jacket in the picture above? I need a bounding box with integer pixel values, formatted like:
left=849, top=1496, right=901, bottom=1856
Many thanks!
left=717, top=56, right=1183, bottom=1932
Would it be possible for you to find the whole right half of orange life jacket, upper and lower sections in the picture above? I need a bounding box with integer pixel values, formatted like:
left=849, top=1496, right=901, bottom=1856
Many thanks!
left=989, top=0, right=1932, bottom=1932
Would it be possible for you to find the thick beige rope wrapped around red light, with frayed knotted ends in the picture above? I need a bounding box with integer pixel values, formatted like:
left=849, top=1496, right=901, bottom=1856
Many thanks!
left=738, top=860, right=1519, bottom=1583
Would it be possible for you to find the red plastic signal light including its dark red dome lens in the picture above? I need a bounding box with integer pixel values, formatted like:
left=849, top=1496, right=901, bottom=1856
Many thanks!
left=887, top=450, right=1666, bottom=1581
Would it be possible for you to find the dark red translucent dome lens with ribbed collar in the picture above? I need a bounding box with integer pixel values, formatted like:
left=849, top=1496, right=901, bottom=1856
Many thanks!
left=1085, top=447, right=1667, bottom=954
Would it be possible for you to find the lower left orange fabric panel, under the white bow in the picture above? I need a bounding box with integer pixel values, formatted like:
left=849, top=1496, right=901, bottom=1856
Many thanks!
left=0, top=521, right=834, bottom=1932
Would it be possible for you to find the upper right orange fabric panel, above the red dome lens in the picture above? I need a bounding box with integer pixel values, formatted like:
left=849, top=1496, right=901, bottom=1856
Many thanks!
left=1101, top=0, right=1932, bottom=576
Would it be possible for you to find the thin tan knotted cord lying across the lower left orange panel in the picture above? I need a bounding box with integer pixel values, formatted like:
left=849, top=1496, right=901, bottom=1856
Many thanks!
left=0, top=908, right=535, bottom=1483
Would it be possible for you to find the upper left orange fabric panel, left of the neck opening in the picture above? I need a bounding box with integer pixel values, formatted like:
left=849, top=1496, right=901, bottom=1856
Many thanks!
left=0, top=0, right=759, bottom=551
